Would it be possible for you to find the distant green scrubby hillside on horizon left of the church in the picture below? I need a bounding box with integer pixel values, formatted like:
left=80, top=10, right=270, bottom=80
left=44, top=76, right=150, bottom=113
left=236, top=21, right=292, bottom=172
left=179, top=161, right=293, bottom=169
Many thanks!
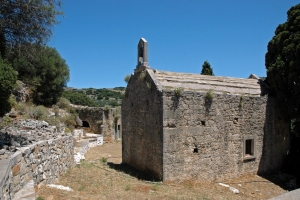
left=63, top=87, right=125, bottom=107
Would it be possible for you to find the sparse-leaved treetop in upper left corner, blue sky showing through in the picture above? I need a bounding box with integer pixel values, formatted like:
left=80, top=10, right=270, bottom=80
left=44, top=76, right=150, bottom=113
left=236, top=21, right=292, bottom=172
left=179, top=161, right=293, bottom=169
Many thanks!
left=0, top=0, right=62, bottom=56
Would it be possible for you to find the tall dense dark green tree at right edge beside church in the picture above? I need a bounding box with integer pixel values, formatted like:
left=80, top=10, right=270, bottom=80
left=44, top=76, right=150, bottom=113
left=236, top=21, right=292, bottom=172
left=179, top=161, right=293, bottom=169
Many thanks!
left=265, top=4, right=300, bottom=124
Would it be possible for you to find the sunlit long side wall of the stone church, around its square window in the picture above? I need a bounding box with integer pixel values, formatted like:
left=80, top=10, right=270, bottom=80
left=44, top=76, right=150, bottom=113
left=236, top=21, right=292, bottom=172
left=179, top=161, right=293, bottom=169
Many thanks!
left=163, top=90, right=288, bottom=182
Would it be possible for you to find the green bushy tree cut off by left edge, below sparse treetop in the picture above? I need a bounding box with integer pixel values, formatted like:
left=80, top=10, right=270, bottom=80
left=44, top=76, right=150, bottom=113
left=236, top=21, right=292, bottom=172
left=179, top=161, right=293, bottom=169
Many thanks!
left=0, top=56, right=17, bottom=116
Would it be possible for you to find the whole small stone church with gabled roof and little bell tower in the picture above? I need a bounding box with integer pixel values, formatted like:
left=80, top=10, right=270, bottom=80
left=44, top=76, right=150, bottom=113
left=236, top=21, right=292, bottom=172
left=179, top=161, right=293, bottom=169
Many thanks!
left=122, top=38, right=290, bottom=182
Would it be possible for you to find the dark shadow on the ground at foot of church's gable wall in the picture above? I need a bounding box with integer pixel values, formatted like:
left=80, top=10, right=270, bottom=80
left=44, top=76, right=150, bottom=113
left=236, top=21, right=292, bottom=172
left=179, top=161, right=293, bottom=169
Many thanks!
left=107, top=162, right=161, bottom=182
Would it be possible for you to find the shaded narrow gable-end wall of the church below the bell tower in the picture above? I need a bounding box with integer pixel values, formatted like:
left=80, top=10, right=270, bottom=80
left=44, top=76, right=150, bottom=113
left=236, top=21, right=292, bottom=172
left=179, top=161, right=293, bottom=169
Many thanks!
left=122, top=71, right=163, bottom=178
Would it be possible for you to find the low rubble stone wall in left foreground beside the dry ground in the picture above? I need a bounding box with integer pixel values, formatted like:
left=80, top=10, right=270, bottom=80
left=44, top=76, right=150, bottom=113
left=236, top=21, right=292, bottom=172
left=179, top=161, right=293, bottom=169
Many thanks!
left=0, top=135, right=75, bottom=199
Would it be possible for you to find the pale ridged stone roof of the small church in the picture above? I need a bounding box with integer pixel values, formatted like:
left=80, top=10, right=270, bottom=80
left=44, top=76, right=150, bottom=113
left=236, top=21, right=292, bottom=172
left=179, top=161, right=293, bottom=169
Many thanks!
left=147, top=69, right=262, bottom=95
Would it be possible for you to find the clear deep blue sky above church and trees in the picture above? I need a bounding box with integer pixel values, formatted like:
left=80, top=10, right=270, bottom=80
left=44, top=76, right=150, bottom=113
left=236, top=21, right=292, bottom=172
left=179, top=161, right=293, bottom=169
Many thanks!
left=48, top=0, right=299, bottom=88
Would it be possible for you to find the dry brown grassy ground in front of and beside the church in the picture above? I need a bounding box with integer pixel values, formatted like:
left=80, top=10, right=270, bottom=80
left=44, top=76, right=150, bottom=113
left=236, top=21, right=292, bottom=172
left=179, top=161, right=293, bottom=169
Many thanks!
left=38, top=142, right=286, bottom=200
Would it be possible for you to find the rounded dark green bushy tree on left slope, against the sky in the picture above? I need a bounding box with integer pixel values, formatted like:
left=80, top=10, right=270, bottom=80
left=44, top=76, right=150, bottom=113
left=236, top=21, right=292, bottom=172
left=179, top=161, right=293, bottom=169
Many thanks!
left=12, top=44, right=70, bottom=106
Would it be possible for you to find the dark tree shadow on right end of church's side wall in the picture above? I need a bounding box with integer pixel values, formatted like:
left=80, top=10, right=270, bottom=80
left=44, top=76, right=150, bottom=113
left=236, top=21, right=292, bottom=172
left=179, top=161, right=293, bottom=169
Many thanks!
left=258, top=95, right=295, bottom=189
